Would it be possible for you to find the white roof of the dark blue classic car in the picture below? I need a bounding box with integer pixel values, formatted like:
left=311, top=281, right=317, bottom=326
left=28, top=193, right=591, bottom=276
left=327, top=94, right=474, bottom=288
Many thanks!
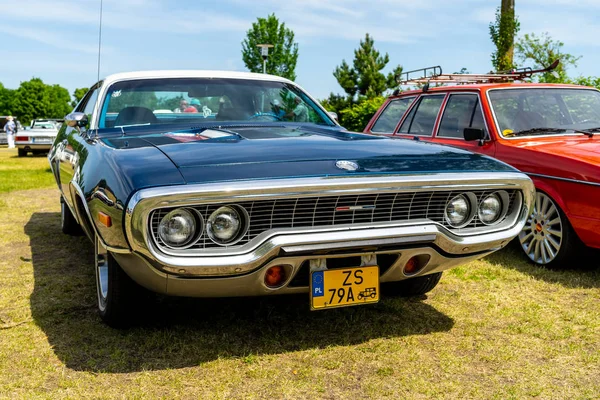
left=104, top=70, right=292, bottom=84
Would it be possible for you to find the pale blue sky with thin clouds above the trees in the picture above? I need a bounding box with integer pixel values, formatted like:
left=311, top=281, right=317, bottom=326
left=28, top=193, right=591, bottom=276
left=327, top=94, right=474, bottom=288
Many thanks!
left=0, top=0, right=600, bottom=99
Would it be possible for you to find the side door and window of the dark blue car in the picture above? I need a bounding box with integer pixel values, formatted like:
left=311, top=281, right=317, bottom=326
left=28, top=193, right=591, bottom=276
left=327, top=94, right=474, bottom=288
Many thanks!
left=56, top=85, right=99, bottom=209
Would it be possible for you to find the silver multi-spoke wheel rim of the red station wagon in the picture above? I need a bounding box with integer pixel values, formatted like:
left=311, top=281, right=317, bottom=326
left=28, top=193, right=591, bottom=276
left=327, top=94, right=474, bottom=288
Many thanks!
left=519, top=192, right=563, bottom=265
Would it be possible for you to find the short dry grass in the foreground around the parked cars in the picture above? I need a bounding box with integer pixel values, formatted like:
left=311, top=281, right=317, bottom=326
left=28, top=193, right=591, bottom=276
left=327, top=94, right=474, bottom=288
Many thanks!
left=0, top=155, right=600, bottom=399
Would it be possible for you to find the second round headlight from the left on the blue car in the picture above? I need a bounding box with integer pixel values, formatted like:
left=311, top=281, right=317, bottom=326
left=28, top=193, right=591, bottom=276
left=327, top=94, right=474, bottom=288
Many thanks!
left=206, top=206, right=248, bottom=245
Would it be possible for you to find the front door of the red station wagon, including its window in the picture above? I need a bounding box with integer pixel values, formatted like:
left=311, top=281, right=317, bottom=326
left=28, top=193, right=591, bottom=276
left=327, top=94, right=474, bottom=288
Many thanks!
left=433, top=93, right=496, bottom=157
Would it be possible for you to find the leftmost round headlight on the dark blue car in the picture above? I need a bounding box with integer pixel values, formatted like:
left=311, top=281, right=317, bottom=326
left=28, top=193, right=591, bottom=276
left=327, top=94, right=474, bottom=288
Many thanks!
left=158, top=208, right=202, bottom=247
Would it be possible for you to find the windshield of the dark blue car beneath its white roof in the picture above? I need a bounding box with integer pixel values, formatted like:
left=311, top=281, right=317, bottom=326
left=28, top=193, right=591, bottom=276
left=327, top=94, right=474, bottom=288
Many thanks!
left=98, top=78, right=335, bottom=128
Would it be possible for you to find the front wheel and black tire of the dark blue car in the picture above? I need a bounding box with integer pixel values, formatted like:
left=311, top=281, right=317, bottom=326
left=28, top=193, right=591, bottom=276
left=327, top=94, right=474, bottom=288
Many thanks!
left=94, top=237, right=144, bottom=328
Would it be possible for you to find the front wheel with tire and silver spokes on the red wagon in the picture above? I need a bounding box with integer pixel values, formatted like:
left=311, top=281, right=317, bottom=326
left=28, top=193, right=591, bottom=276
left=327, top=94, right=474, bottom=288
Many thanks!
left=519, top=192, right=578, bottom=268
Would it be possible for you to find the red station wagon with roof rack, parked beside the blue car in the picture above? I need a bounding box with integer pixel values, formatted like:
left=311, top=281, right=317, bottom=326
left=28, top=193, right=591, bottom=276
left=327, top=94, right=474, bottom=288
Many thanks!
left=365, top=63, right=600, bottom=267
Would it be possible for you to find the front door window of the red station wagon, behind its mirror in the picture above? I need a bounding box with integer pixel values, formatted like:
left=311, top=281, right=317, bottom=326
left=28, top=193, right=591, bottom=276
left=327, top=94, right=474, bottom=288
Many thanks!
left=438, top=94, right=485, bottom=139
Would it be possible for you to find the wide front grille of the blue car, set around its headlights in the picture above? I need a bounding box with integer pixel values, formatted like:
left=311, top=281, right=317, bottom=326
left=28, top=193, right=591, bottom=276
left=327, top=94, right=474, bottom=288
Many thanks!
left=150, top=190, right=517, bottom=249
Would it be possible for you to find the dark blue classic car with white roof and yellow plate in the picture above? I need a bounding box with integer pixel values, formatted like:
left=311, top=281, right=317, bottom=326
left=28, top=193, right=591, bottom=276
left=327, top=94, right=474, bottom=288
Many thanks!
left=49, top=71, right=533, bottom=326
